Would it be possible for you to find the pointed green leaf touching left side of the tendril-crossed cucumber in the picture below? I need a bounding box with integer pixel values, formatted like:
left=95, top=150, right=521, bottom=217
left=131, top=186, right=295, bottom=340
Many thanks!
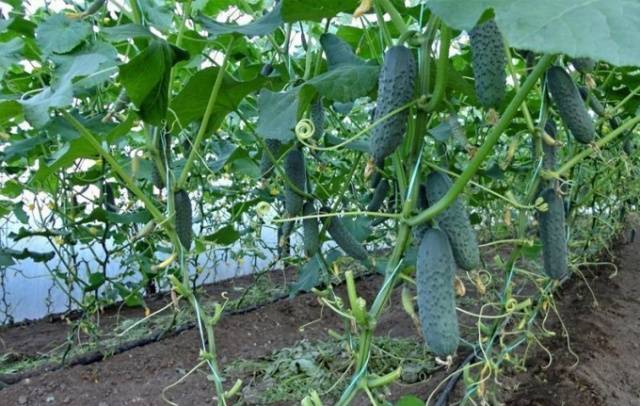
left=307, top=64, right=379, bottom=103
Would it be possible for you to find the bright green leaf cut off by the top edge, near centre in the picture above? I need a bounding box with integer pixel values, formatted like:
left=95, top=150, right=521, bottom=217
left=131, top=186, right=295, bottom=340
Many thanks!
left=281, top=0, right=360, bottom=22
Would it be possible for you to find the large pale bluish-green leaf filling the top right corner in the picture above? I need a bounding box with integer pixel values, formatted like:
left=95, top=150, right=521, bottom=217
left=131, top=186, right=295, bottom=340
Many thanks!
left=427, top=0, right=640, bottom=66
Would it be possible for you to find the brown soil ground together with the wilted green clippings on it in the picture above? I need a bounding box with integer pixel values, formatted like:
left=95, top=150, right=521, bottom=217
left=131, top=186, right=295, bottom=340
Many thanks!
left=0, top=232, right=640, bottom=406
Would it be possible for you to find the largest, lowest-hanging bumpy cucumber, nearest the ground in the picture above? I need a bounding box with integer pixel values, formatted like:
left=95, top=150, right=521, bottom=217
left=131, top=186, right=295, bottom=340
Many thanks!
left=416, top=228, right=460, bottom=358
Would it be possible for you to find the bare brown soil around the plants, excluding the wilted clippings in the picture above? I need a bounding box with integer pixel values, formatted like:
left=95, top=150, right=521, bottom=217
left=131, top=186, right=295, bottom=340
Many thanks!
left=0, top=232, right=640, bottom=406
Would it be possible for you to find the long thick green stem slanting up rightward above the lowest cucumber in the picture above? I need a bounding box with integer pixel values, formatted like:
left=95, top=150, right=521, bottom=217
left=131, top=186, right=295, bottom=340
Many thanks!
left=406, top=55, right=556, bottom=226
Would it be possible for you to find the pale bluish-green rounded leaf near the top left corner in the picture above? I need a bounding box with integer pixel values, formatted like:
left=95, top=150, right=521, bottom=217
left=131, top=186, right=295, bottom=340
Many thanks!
left=36, top=14, right=91, bottom=55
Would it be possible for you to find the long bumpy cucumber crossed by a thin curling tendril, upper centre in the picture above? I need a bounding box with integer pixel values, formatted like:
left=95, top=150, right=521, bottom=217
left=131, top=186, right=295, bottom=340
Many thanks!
left=369, top=46, right=418, bottom=165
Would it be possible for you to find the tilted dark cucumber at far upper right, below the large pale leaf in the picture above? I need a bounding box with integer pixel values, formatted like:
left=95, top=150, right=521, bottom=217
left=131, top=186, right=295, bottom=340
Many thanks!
left=547, top=66, right=596, bottom=144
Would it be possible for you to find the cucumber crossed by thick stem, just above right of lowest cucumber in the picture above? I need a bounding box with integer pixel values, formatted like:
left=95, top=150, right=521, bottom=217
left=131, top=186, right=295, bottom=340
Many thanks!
left=426, top=172, right=480, bottom=271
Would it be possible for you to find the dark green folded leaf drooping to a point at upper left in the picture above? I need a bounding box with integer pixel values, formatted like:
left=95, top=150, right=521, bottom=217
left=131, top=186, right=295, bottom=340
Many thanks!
left=120, top=39, right=188, bottom=125
